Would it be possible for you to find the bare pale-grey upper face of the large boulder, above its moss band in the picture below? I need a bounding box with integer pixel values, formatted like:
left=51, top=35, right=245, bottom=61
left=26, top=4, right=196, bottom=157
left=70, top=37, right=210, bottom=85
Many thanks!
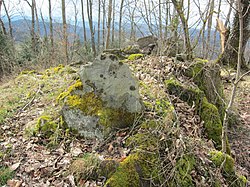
left=79, top=55, right=143, bottom=113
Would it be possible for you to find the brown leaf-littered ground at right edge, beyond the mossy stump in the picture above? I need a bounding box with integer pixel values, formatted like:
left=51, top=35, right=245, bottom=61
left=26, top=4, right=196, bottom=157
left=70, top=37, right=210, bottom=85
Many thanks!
left=224, top=72, right=250, bottom=179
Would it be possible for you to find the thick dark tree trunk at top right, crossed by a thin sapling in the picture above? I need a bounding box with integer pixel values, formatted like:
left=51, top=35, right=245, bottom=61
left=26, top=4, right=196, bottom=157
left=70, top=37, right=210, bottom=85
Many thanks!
left=219, top=0, right=250, bottom=69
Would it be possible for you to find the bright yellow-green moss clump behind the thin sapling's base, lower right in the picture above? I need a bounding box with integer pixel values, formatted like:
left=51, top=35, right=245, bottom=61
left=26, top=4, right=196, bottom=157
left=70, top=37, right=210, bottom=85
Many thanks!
left=209, top=151, right=235, bottom=175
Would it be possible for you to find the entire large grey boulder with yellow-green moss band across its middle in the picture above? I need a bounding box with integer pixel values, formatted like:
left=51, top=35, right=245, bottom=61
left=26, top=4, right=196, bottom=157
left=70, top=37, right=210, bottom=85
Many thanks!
left=62, top=55, right=143, bottom=139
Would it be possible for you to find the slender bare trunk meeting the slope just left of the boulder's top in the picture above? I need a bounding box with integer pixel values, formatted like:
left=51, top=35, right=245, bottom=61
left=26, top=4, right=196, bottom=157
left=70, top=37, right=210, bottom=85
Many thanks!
left=87, top=0, right=96, bottom=57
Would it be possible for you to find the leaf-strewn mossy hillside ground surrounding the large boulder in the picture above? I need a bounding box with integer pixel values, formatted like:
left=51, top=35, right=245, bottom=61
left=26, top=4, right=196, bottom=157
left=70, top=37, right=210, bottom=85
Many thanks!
left=0, top=57, right=250, bottom=186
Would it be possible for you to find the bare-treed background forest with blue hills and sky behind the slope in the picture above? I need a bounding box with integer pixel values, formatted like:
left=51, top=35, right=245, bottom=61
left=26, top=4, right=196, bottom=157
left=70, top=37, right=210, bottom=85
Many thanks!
left=0, top=0, right=249, bottom=78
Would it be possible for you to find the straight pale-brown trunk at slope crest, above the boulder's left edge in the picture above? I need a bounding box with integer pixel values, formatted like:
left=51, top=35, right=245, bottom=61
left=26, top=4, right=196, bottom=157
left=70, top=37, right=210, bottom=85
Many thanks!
left=62, top=0, right=69, bottom=63
